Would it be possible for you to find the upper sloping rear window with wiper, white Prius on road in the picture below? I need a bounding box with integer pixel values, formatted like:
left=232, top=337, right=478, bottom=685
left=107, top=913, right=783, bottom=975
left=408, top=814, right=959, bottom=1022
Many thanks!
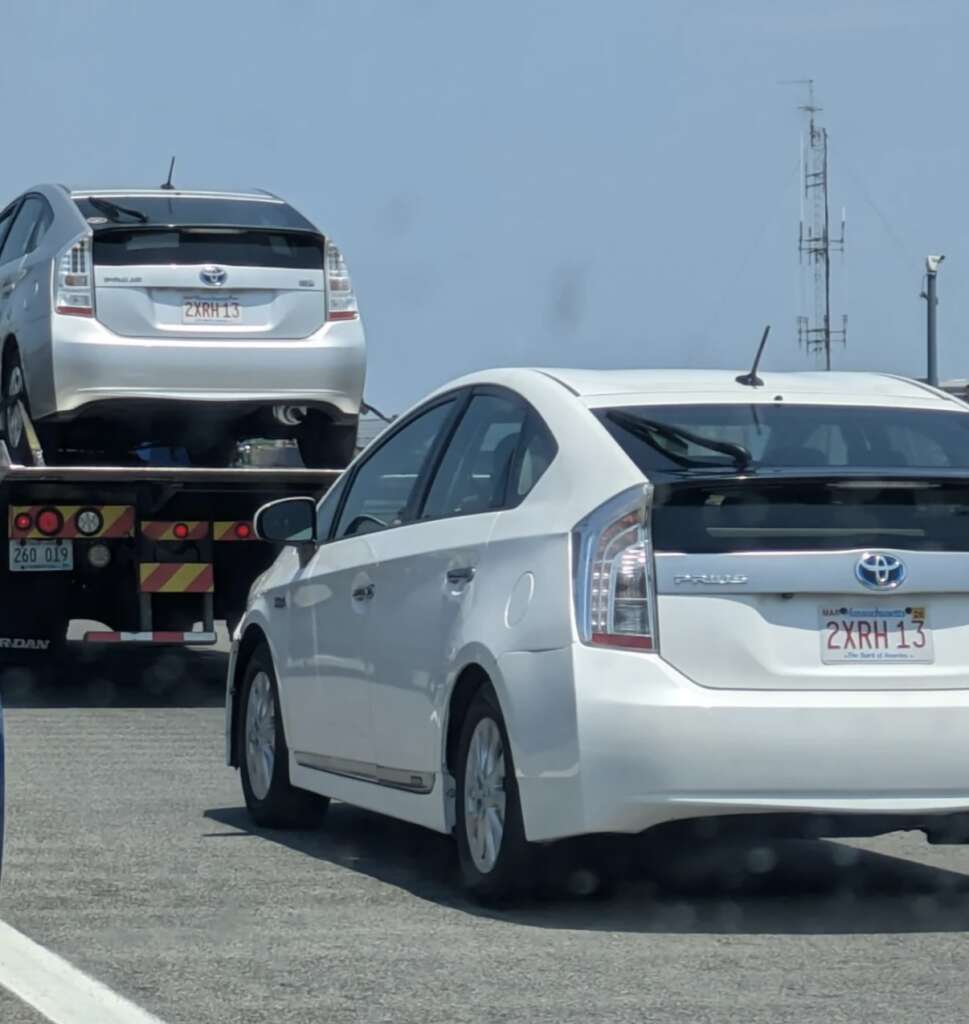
left=595, top=402, right=969, bottom=476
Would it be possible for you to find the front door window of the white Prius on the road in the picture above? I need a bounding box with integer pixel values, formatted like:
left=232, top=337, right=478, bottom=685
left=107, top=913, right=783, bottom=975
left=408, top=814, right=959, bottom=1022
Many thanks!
left=335, top=398, right=456, bottom=540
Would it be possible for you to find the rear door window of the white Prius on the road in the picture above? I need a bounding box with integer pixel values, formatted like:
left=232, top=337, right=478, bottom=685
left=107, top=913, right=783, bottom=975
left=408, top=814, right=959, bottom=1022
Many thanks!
left=422, top=394, right=528, bottom=519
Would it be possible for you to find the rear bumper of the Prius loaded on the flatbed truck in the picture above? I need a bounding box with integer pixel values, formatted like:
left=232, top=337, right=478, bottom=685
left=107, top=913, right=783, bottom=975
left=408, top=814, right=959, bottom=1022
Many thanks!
left=46, top=315, right=366, bottom=419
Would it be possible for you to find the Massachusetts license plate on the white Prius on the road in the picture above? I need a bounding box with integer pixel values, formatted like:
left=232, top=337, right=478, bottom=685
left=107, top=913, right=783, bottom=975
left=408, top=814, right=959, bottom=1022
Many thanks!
left=819, top=605, right=934, bottom=664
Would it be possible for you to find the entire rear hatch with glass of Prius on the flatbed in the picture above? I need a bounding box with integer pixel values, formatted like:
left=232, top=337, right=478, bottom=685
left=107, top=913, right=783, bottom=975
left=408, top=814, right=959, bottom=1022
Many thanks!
left=76, top=196, right=326, bottom=341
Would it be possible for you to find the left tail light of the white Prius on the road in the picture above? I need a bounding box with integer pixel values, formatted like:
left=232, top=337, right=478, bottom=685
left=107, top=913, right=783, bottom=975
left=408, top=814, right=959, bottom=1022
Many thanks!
left=573, top=484, right=657, bottom=651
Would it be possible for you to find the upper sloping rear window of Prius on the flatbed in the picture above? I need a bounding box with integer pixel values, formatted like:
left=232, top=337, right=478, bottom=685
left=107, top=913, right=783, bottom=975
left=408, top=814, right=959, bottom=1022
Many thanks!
left=74, top=195, right=317, bottom=231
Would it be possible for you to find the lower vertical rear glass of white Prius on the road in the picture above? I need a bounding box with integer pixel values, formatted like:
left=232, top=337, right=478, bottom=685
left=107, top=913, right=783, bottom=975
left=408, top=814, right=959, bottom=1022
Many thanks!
left=651, top=477, right=969, bottom=554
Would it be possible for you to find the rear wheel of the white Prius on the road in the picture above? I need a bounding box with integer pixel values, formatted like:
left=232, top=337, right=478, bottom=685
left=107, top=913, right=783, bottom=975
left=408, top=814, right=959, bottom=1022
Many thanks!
left=456, top=684, right=533, bottom=904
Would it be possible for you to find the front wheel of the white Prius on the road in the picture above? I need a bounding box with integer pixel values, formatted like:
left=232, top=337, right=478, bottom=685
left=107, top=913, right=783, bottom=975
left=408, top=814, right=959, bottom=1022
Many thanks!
left=239, top=647, right=330, bottom=828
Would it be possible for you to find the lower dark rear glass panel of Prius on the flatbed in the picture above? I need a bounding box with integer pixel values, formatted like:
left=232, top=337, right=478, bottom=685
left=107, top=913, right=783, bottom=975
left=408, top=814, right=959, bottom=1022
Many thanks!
left=94, top=227, right=324, bottom=270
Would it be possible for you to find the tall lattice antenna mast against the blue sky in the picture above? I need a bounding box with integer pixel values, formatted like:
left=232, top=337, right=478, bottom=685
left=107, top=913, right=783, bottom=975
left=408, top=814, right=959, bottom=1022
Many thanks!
left=791, top=78, right=848, bottom=370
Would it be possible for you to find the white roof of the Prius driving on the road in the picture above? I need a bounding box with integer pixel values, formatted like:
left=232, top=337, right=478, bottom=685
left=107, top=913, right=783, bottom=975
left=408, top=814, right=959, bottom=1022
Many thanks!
left=438, top=368, right=967, bottom=412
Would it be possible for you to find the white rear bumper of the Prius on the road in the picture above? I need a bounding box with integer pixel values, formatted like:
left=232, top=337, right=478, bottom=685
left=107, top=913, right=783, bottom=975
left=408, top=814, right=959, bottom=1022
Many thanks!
left=502, top=645, right=969, bottom=840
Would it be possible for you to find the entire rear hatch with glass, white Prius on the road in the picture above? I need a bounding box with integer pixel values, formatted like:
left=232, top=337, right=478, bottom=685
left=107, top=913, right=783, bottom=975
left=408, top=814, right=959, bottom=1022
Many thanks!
left=606, top=397, right=969, bottom=690
